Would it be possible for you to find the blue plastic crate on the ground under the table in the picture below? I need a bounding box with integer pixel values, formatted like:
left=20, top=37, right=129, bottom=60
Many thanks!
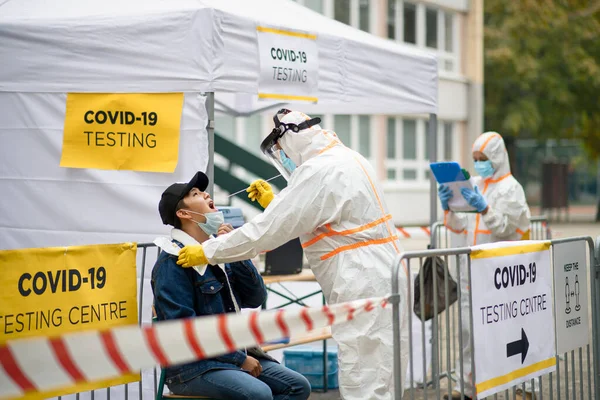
left=283, top=346, right=338, bottom=389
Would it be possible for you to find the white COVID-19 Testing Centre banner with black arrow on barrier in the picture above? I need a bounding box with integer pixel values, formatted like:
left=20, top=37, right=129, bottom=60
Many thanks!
left=471, top=241, right=556, bottom=398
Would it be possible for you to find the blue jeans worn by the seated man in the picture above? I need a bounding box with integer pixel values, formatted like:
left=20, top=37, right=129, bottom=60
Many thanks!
left=169, top=359, right=310, bottom=400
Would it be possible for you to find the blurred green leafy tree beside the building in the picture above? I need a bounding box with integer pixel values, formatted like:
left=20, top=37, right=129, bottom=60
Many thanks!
left=484, top=0, right=600, bottom=220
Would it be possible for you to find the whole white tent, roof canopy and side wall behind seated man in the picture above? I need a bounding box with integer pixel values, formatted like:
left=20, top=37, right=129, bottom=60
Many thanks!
left=0, top=0, right=437, bottom=248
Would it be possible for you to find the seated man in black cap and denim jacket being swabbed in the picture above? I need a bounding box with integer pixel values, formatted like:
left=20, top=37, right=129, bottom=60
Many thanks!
left=152, top=172, right=310, bottom=400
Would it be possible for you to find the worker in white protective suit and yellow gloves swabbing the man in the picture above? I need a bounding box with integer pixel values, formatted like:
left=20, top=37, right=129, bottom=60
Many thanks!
left=179, top=109, right=409, bottom=400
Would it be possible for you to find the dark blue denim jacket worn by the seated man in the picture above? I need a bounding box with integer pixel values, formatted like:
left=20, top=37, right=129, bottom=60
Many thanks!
left=151, top=230, right=270, bottom=384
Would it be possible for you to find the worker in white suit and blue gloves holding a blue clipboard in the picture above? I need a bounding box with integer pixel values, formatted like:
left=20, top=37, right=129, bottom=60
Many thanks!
left=439, top=132, right=532, bottom=399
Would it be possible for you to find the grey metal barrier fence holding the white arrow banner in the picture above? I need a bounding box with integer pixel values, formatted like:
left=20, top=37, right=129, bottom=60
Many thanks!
left=392, top=237, right=600, bottom=400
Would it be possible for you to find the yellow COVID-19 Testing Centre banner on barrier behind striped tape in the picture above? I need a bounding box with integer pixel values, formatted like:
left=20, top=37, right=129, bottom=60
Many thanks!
left=0, top=243, right=140, bottom=399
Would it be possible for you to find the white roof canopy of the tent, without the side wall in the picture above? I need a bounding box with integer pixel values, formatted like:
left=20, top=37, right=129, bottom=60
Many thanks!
left=0, top=0, right=437, bottom=114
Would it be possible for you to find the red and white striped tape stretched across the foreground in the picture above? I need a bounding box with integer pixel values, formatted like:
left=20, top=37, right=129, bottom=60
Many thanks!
left=0, top=298, right=387, bottom=399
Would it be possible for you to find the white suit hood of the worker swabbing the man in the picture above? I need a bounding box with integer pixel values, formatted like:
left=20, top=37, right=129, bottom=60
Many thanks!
left=278, top=111, right=341, bottom=166
